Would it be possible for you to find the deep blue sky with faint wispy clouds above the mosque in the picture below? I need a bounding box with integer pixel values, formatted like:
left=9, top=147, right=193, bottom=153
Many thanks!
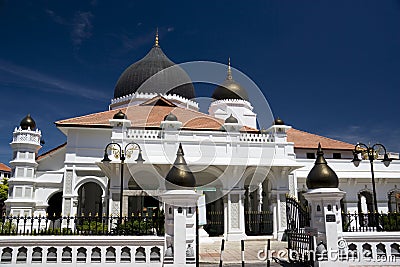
left=0, top=0, right=400, bottom=163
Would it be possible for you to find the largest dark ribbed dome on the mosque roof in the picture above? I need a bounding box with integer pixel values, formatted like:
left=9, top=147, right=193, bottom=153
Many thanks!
left=114, top=42, right=195, bottom=99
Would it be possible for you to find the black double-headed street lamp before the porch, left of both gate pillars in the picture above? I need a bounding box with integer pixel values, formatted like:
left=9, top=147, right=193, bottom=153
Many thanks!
left=101, top=142, right=145, bottom=222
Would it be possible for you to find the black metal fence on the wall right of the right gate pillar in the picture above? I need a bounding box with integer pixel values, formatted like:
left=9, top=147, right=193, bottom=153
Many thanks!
left=342, top=212, right=400, bottom=232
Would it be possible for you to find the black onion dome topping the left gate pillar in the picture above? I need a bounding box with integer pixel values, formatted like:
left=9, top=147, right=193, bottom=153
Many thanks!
left=165, top=144, right=196, bottom=190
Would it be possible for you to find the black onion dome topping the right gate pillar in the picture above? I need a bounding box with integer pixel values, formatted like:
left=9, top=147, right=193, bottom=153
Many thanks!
left=306, top=144, right=339, bottom=189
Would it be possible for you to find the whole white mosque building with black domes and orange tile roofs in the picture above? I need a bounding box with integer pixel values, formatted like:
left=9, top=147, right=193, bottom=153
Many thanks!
left=6, top=34, right=400, bottom=240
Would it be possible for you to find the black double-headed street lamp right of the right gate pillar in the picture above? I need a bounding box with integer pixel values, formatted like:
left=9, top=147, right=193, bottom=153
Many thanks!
left=351, top=143, right=392, bottom=226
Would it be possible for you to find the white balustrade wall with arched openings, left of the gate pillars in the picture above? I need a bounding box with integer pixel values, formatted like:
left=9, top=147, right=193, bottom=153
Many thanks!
left=0, top=236, right=164, bottom=267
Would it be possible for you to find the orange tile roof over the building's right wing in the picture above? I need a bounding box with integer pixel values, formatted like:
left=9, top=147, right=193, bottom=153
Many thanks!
left=287, top=128, right=354, bottom=150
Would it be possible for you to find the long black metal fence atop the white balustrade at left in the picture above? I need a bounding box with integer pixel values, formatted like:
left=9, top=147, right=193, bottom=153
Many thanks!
left=0, top=212, right=164, bottom=236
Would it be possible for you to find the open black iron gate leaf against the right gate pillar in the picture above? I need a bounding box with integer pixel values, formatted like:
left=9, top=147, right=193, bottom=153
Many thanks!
left=286, top=195, right=314, bottom=266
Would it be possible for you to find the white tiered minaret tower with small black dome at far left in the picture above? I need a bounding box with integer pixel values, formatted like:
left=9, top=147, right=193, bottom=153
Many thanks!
left=6, top=114, right=42, bottom=216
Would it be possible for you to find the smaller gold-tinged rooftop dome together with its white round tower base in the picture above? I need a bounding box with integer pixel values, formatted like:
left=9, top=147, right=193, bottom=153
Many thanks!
left=208, top=58, right=257, bottom=128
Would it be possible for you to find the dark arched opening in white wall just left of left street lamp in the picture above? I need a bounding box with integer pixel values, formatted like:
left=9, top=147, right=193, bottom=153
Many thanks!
left=78, top=182, right=103, bottom=216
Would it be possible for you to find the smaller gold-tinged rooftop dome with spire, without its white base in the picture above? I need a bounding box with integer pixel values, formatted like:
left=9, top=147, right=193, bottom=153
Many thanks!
left=212, top=59, right=249, bottom=101
